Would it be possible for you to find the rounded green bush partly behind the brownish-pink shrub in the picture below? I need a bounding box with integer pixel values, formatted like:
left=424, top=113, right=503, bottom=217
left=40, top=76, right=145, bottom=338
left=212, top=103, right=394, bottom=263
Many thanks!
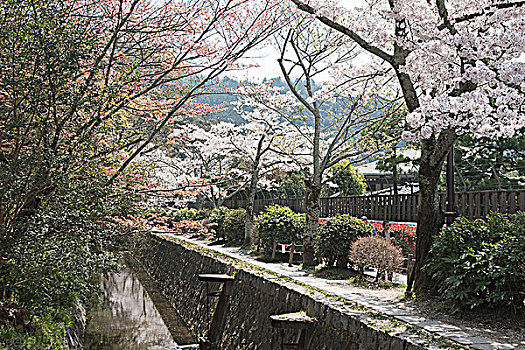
left=315, top=214, right=373, bottom=267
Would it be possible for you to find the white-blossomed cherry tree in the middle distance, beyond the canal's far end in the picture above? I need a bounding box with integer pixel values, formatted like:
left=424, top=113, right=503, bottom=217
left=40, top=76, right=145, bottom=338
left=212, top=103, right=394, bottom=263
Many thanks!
left=147, top=95, right=293, bottom=245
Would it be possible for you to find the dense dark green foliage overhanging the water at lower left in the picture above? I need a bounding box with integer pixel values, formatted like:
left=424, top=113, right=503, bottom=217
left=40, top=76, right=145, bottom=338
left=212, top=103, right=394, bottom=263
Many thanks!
left=0, top=160, right=133, bottom=349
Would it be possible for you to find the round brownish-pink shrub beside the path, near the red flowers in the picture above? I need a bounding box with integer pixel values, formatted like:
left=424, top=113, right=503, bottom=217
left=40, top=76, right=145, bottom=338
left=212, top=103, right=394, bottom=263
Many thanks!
left=349, top=236, right=403, bottom=281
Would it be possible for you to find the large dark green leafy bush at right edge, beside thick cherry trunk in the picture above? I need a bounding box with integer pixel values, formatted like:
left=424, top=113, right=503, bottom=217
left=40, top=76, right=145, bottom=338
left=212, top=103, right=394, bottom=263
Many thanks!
left=425, top=213, right=525, bottom=308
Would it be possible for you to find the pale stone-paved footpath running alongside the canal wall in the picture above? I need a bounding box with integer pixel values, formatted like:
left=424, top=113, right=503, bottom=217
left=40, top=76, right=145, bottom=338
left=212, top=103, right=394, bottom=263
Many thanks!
left=165, top=232, right=525, bottom=350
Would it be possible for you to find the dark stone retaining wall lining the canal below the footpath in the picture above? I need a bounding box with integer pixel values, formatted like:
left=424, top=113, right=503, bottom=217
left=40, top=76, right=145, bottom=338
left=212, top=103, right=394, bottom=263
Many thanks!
left=134, top=234, right=454, bottom=350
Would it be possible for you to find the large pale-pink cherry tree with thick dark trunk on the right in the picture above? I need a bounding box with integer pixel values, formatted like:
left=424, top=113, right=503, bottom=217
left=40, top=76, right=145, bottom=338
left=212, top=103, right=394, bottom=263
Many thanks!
left=292, top=0, right=525, bottom=293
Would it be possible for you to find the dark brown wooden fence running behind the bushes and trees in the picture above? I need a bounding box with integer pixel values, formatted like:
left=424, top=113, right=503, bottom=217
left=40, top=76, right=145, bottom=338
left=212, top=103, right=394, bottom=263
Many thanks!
left=224, top=189, right=525, bottom=222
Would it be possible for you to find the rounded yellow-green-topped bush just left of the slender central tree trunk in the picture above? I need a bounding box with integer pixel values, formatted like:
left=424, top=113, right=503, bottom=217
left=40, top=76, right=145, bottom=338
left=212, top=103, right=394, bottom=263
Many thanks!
left=256, top=205, right=305, bottom=250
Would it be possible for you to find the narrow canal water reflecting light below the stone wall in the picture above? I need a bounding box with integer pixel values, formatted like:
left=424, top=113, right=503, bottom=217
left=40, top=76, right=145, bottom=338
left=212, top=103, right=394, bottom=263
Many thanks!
left=84, top=266, right=198, bottom=350
